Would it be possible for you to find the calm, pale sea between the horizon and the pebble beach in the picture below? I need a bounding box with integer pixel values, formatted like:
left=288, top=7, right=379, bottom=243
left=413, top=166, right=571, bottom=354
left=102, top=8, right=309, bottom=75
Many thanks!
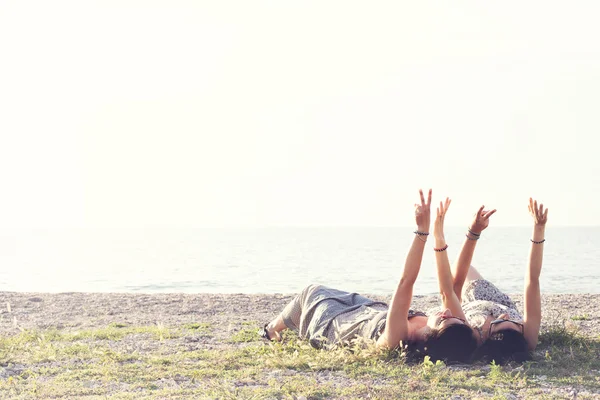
left=0, top=227, right=600, bottom=294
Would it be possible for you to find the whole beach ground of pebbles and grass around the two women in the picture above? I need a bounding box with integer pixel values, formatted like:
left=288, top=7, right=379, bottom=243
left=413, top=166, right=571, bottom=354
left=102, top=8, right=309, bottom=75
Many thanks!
left=0, top=292, right=600, bottom=399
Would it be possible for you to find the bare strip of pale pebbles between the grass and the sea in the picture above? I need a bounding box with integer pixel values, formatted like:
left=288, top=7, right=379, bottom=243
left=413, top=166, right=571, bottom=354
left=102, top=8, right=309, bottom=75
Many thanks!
left=0, top=292, right=600, bottom=337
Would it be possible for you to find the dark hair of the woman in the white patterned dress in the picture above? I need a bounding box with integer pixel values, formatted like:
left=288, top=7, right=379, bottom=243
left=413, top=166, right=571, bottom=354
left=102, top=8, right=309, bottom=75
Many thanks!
left=473, top=329, right=531, bottom=365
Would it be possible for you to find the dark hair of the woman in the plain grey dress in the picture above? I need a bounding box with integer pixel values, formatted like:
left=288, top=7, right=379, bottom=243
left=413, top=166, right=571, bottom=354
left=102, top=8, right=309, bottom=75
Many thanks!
left=405, top=324, right=477, bottom=364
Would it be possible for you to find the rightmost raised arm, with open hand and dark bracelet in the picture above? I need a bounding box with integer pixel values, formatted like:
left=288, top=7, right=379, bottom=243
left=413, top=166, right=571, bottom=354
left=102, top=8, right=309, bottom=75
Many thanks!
left=523, top=198, right=548, bottom=350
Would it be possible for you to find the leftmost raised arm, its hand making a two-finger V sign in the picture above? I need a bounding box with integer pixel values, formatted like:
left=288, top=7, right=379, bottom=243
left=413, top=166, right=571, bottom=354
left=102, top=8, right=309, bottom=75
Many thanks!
left=377, top=189, right=431, bottom=348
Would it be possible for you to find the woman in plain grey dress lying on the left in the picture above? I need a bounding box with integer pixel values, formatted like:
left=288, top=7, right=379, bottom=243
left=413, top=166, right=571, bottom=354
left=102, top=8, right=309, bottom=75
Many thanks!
left=261, top=190, right=477, bottom=362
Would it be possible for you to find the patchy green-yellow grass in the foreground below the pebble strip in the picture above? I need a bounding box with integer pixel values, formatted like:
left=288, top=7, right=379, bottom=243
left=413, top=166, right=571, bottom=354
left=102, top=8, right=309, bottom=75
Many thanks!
left=0, top=322, right=600, bottom=399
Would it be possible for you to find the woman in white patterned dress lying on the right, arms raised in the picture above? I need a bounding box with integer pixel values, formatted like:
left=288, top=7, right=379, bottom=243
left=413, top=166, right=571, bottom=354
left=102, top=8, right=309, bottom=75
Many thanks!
left=452, top=198, right=548, bottom=364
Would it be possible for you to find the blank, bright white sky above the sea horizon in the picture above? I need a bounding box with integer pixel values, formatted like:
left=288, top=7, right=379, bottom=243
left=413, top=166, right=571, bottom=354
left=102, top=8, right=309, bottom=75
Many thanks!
left=0, top=0, right=600, bottom=228
